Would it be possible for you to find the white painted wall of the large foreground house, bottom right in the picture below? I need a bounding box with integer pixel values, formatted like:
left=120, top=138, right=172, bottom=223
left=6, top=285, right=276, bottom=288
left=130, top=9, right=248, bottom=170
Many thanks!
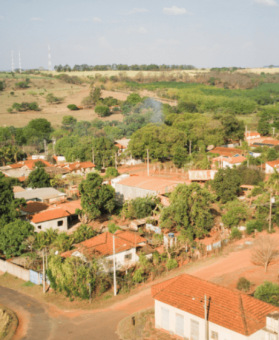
left=155, top=300, right=265, bottom=340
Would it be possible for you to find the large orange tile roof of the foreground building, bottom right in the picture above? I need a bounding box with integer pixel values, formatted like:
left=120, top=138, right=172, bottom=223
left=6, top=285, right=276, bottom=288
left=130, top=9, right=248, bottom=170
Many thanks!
left=152, top=274, right=279, bottom=336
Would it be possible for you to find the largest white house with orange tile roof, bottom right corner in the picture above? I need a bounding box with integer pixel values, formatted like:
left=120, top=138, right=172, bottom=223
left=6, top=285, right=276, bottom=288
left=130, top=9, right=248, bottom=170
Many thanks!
left=152, top=274, right=279, bottom=340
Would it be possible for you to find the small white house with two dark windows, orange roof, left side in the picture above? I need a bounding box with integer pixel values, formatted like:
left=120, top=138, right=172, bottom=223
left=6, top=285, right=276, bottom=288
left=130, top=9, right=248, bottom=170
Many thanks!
left=29, top=208, right=70, bottom=232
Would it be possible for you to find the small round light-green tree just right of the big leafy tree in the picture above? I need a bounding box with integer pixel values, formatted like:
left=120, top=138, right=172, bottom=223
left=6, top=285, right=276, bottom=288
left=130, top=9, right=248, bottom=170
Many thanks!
left=222, top=200, right=249, bottom=228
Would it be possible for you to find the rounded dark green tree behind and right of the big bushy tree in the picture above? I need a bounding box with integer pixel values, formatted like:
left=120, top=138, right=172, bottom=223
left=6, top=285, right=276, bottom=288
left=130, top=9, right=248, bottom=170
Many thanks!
left=211, top=168, right=241, bottom=203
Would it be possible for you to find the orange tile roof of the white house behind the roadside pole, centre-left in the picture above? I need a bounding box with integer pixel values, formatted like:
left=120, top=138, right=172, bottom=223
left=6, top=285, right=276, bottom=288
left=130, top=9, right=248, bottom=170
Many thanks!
left=61, top=230, right=146, bottom=257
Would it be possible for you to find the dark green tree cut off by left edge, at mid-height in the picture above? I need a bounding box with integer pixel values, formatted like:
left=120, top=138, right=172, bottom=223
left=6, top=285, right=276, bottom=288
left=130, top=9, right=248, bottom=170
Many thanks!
left=0, top=173, right=26, bottom=227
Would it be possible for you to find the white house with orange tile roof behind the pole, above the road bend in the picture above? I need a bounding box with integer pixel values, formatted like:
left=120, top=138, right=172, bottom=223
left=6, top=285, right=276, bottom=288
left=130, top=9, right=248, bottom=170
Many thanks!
left=61, top=230, right=152, bottom=271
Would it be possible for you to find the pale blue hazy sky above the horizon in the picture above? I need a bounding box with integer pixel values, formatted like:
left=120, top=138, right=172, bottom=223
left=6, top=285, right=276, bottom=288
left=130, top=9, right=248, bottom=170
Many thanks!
left=0, top=0, right=279, bottom=70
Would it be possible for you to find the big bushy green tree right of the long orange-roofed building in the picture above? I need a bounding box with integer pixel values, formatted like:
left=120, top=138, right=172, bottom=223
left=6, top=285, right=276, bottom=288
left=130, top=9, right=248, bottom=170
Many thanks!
left=161, top=183, right=215, bottom=240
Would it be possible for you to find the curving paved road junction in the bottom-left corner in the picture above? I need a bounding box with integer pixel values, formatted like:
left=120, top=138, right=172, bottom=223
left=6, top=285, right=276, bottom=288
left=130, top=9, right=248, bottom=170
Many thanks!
left=0, top=286, right=129, bottom=340
